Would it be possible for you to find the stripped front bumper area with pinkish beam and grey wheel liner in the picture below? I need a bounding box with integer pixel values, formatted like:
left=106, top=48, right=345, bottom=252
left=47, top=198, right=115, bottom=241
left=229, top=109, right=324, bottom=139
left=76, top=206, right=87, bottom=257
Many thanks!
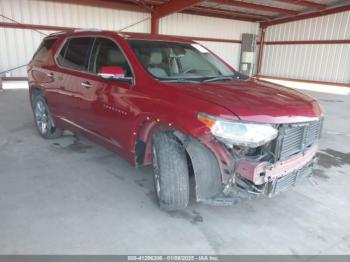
left=184, top=134, right=317, bottom=205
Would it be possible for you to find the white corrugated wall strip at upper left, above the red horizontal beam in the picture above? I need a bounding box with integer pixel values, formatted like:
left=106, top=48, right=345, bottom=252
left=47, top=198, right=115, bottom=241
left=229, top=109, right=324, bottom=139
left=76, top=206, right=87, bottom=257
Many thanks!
left=0, top=0, right=150, bottom=33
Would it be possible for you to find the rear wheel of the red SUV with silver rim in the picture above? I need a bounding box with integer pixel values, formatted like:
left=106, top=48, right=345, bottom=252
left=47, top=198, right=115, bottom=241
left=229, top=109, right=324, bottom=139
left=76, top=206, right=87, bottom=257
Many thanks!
left=33, top=95, right=63, bottom=139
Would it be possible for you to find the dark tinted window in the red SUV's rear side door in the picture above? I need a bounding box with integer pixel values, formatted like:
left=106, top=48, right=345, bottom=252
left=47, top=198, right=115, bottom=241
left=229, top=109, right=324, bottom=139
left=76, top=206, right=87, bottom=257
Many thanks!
left=61, top=37, right=93, bottom=71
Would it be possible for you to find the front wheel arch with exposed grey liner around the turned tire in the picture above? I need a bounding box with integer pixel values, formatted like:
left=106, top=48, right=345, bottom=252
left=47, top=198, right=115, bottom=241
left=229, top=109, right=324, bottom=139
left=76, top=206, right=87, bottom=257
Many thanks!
left=134, top=113, right=222, bottom=201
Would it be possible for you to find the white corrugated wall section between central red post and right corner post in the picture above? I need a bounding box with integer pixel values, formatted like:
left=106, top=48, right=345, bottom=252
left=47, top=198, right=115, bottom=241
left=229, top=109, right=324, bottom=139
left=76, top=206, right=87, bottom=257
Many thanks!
left=159, top=13, right=259, bottom=69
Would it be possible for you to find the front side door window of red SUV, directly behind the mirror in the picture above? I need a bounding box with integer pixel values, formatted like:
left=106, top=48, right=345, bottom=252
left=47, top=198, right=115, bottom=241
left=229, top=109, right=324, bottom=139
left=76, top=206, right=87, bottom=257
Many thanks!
left=90, top=38, right=132, bottom=77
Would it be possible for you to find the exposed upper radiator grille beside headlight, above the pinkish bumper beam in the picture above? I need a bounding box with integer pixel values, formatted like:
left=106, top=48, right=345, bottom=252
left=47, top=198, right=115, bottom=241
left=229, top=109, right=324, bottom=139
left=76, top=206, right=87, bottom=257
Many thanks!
left=275, top=121, right=322, bottom=160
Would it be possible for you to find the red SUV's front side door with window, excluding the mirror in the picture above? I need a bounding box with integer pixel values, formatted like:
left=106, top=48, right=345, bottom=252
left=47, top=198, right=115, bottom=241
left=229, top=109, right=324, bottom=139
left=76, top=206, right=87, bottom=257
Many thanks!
left=81, top=37, right=133, bottom=149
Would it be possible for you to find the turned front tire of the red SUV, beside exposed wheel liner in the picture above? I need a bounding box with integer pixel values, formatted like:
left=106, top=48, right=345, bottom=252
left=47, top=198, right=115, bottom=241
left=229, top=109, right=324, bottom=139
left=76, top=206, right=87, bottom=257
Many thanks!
left=152, top=132, right=190, bottom=211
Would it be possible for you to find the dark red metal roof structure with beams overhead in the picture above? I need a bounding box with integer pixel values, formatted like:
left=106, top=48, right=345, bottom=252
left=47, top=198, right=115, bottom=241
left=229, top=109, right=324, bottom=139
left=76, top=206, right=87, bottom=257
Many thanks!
left=61, top=0, right=350, bottom=33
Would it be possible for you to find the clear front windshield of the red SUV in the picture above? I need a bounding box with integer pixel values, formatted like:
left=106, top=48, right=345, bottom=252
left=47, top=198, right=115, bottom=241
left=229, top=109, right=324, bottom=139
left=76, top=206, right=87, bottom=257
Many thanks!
left=128, top=40, right=235, bottom=82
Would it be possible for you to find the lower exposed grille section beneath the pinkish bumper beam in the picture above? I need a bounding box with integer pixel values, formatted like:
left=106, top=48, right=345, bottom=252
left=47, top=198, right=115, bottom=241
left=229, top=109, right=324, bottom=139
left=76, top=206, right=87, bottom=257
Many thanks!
left=268, top=162, right=313, bottom=197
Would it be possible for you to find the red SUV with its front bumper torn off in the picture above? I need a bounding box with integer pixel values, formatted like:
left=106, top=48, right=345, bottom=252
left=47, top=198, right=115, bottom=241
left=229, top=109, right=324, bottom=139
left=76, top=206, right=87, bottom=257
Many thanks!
left=28, top=30, right=323, bottom=210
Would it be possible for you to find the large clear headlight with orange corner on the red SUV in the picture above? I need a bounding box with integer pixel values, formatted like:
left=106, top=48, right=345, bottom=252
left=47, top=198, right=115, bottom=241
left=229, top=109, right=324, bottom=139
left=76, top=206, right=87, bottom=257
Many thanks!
left=197, top=113, right=278, bottom=147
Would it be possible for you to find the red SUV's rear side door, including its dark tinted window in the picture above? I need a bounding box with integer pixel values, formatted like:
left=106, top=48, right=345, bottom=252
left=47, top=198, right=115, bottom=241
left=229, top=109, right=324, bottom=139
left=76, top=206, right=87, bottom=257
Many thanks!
left=56, top=36, right=95, bottom=127
